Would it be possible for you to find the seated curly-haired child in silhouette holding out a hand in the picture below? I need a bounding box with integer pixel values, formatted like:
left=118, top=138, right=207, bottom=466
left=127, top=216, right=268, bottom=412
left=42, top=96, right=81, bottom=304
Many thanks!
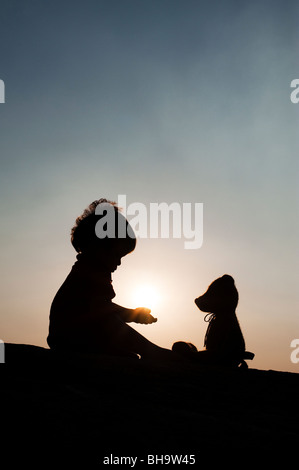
left=47, top=199, right=174, bottom=358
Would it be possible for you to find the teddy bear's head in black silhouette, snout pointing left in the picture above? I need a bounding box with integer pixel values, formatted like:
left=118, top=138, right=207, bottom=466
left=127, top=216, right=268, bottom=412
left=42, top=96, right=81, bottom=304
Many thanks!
left=195, top=274, right=239, bottom=313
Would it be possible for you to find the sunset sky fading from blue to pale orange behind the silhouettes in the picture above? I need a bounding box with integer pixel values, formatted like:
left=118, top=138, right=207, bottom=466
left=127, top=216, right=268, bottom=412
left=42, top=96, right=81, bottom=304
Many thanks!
left=0, top=0, right=299, bottom=372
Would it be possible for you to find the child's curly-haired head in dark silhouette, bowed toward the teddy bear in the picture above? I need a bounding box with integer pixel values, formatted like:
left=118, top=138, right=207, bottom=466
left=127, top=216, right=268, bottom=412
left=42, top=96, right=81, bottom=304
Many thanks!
left=71, top=199, right=136, bottom=271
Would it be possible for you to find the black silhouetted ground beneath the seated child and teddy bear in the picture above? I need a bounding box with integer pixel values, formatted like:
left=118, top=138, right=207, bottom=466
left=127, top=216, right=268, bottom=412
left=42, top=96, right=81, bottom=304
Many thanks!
left=0, top=344, right=299, bottom=469
